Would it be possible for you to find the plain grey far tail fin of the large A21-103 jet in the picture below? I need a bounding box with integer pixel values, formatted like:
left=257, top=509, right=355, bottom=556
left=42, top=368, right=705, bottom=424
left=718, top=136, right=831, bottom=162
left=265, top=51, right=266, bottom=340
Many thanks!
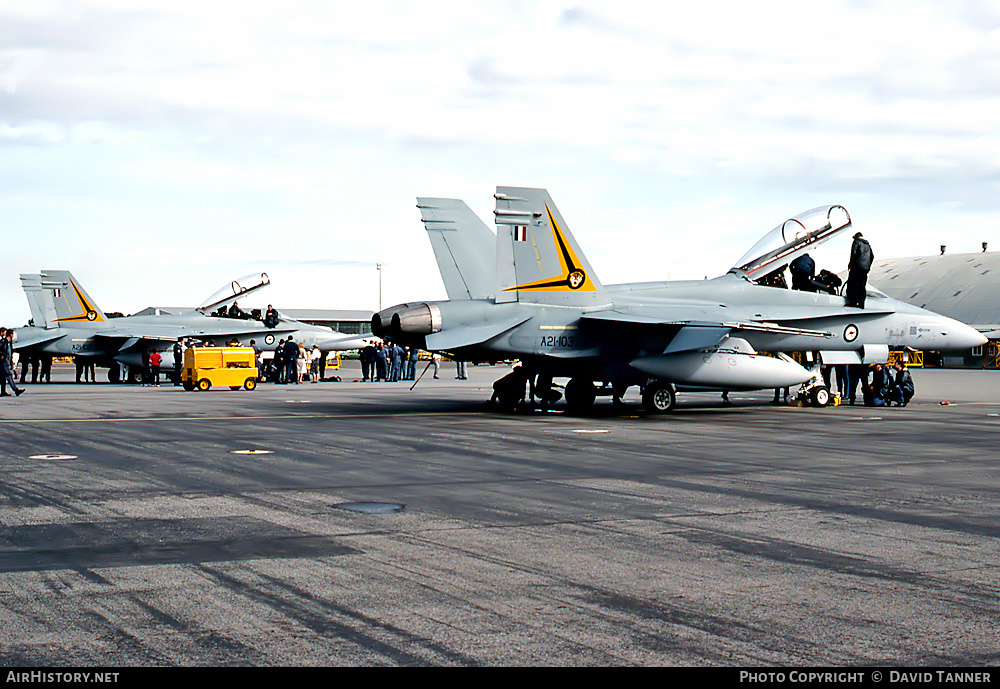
left=417, top=198, right=496, bottom=299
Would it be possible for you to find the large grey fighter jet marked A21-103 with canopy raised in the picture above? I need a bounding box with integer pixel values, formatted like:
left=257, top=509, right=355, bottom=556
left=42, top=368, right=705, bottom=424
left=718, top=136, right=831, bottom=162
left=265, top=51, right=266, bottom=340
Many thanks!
left=372, top=187, right=985, bottom=413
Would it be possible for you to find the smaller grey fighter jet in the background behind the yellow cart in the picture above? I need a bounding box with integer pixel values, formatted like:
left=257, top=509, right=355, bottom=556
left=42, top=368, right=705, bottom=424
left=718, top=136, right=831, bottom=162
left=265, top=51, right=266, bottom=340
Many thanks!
left=14, top=270, right=368, bottom=382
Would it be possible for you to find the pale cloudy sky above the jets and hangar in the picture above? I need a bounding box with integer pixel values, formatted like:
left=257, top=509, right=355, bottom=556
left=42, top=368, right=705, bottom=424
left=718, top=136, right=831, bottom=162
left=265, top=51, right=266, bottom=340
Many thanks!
left=0, top=0, right=1000, bottom=326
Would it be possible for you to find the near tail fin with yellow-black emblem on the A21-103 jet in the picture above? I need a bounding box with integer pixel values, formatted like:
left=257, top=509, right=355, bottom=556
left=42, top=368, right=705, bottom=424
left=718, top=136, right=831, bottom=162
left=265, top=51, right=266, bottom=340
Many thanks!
left=494, top=187, right=608, bottom=306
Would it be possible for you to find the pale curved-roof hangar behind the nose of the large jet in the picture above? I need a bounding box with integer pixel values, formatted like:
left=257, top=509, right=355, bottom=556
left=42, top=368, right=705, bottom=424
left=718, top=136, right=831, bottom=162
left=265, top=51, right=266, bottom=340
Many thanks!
left=868, top=245, right=1000, bottom=367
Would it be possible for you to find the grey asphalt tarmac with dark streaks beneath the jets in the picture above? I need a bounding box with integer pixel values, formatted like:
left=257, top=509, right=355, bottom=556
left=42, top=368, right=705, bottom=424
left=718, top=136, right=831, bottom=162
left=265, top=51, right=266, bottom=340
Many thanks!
left=0, top=362, right=1000, bottom=667
